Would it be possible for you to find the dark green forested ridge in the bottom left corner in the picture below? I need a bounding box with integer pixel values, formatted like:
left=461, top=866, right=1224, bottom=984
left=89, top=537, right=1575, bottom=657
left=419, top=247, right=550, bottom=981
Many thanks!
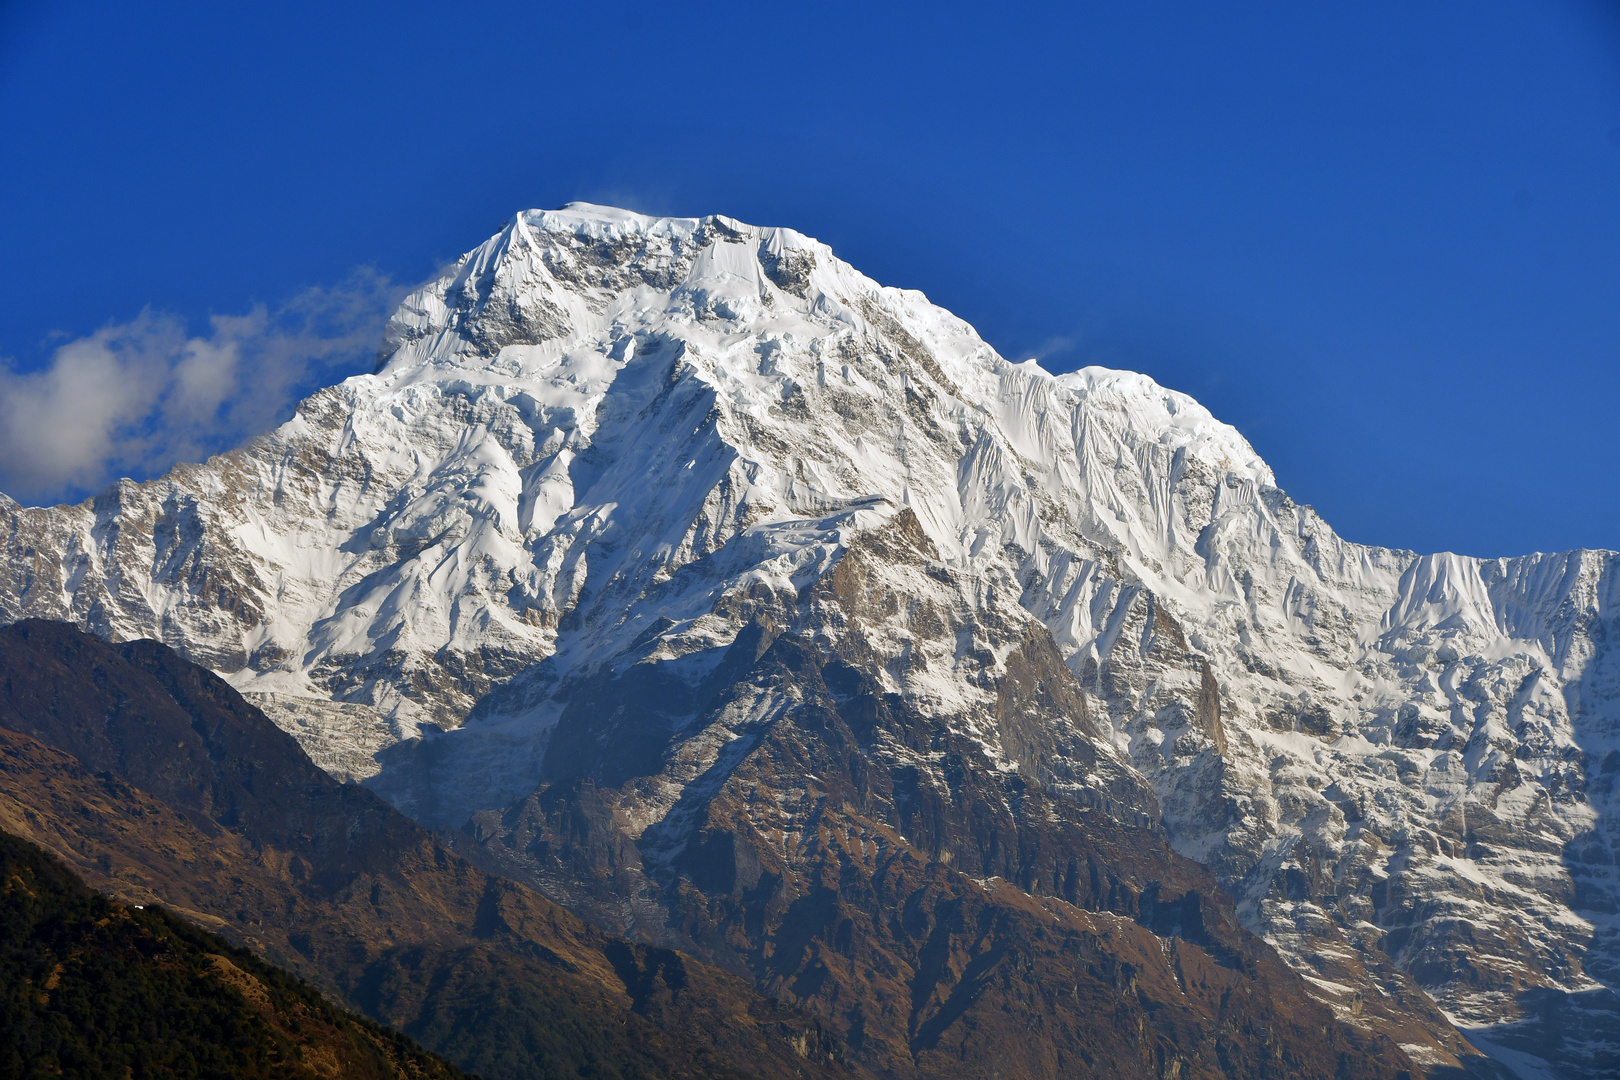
left=0, top=832, right=465, bottom=1080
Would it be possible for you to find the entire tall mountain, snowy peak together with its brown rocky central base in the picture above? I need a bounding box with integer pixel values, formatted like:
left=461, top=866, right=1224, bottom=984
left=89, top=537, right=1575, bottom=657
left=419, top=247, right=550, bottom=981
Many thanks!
left=0, top=204, right=1620, bottom=1077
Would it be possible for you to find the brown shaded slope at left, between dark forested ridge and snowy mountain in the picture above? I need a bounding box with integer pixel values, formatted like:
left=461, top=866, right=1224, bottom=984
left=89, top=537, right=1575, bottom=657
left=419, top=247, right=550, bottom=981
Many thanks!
left=0, top=622, right=846, bottom=1078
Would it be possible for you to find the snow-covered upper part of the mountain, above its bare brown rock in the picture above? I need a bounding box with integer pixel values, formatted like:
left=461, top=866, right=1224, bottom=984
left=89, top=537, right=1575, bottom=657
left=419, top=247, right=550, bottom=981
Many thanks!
left=0, top=204, right=1620, bottom=1077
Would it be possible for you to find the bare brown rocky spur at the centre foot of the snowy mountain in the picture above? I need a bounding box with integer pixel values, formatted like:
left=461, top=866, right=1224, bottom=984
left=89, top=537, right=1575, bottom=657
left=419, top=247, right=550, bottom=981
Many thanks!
left=443, top=513, right=1487, bottom=1080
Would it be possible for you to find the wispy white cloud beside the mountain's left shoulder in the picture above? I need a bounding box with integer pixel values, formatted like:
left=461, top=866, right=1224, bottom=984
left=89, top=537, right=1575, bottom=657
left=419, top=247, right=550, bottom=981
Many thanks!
left=0, top=270, right=405, bottom=505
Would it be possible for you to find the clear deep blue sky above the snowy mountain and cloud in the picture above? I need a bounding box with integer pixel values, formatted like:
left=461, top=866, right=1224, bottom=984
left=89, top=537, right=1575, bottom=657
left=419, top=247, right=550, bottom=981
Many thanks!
left=0, top=0, right=1620, bottom=555
